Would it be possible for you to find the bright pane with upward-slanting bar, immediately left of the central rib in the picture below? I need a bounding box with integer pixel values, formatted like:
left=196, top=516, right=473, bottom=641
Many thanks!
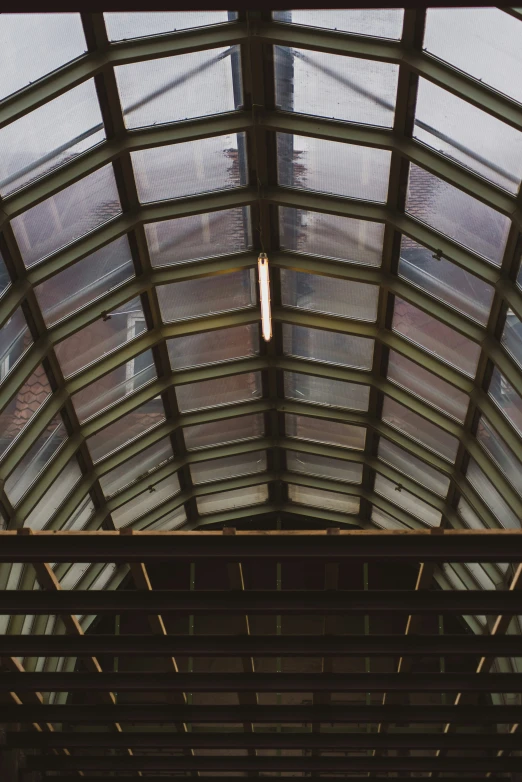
left=114, top=46, right=239, bottom=129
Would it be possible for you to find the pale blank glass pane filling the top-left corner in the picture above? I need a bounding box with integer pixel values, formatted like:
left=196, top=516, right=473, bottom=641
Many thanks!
left=0, top=13, right=87, bottom=100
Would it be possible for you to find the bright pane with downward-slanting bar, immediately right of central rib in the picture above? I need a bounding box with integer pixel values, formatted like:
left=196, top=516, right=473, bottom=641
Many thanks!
left=274, top=46, right=399, bottom=128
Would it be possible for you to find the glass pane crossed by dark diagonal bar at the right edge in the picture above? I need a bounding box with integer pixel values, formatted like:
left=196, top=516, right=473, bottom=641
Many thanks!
left=414, top=77, right=522, bottom=193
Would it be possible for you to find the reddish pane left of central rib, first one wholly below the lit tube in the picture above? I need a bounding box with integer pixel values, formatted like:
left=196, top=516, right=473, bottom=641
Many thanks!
left=176, top=372, right=261, bottom=413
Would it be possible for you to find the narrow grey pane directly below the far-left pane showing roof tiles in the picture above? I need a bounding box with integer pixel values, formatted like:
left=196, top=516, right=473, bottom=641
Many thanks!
left=4, top=415, right=67, bottom=505
